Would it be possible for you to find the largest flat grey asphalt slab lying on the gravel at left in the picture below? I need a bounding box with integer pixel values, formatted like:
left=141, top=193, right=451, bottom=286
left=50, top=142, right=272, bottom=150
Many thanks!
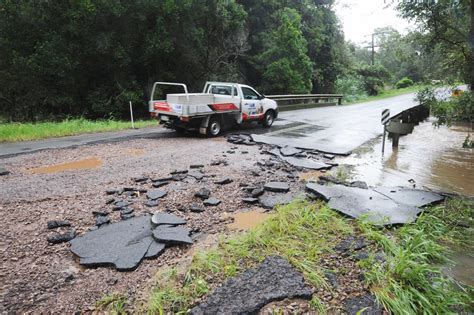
left=71, top=215, right=154, bottom=271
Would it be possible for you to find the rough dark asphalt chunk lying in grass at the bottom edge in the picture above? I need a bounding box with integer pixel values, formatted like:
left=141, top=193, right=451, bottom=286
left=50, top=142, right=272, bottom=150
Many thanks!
left=190, top=256, right=313, bottom=315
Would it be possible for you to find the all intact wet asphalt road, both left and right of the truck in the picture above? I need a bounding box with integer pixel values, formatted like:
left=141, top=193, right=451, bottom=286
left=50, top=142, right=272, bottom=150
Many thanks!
left=0, top=93, right=417, bottom=158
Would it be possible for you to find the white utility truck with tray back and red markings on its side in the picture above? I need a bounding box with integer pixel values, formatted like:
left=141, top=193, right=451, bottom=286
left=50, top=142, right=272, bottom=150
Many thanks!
left=149, top=82, right=278, bottom=137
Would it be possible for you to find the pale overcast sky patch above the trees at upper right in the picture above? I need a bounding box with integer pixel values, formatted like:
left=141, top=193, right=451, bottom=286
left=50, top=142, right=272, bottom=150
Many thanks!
left=335, top=0, right=412, bottom=44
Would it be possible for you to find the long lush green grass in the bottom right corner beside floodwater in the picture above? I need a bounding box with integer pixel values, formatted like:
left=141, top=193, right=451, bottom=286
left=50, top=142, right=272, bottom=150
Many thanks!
left=361, top=199, right=474, bottom=314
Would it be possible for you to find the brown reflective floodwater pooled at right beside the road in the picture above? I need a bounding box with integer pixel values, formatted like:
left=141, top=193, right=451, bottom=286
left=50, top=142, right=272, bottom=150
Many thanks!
left=338, top=120, right=474, bottom=196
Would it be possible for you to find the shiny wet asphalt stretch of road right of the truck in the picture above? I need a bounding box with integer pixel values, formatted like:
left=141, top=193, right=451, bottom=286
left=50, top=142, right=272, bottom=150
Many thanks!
left=254, top=93, right=418, bottom=155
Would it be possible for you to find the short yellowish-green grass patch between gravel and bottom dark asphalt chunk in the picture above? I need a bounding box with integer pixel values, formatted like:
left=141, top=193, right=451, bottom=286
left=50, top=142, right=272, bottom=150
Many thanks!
left=147, top=200, right=353, bottom=314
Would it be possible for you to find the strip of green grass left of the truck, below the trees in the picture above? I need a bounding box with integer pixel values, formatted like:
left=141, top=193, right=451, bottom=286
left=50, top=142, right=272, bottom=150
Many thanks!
left=0, top=118, right=157, bottom=142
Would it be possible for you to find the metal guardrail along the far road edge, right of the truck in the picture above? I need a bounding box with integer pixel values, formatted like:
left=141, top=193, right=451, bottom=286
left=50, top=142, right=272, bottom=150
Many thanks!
left=266, top=94, right=342, bottom=109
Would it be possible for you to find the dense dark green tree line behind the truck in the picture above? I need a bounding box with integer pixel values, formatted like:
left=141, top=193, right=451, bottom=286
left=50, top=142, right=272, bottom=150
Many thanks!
left=0, top=0, right=345, bottom=121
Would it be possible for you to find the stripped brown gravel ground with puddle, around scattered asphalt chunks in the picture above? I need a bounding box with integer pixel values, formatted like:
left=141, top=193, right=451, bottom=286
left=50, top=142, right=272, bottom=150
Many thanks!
left=0, top=133, right=365, bottom=313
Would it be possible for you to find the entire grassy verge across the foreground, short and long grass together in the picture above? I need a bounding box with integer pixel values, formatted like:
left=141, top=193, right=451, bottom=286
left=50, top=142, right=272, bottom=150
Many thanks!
left=120, top=199, right=474, bottom=314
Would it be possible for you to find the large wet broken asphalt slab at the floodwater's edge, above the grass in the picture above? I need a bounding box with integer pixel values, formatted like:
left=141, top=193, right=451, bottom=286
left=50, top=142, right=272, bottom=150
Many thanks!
left=306, top=183, right=444, bottom=225
